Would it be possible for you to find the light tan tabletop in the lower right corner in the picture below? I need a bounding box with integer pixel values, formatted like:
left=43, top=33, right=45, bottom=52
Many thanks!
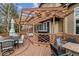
left=63, top=42, right=79, bottom=56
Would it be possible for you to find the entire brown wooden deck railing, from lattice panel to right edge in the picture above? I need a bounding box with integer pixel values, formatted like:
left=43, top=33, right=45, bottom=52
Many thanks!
left=26, top=33, right=79, bottom=44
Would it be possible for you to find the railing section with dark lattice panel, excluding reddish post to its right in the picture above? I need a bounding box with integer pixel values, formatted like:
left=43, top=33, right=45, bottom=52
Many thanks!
left=29, top=33, right=51, bottom=44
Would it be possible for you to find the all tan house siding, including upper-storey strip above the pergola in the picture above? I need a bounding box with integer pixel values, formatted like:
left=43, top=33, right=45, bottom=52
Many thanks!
left=41, top=3, right=79, bottom=34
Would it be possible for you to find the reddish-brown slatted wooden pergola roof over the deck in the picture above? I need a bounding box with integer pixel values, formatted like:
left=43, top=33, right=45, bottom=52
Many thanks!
left=16, top=7, right=73, bottom=34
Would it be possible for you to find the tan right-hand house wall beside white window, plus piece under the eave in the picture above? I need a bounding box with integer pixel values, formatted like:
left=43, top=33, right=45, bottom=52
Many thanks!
left=65, top=4, right=79, bottom=34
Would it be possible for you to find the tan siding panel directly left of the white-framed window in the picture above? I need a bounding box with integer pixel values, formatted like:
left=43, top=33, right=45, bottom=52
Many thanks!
left=65, top=13, right=74, bottom=33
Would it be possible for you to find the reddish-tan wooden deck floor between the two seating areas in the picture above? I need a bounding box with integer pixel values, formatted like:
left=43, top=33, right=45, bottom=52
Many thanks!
left=0, top=37, right=51, bottom=56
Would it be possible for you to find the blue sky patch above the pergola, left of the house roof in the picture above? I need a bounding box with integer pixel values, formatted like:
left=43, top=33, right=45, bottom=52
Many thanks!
left=16, top=3, right=39, bottom=12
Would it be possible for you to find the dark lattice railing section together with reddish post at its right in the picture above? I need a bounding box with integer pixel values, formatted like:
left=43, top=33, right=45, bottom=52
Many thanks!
left=31, top=33, right=59, bottom=44
